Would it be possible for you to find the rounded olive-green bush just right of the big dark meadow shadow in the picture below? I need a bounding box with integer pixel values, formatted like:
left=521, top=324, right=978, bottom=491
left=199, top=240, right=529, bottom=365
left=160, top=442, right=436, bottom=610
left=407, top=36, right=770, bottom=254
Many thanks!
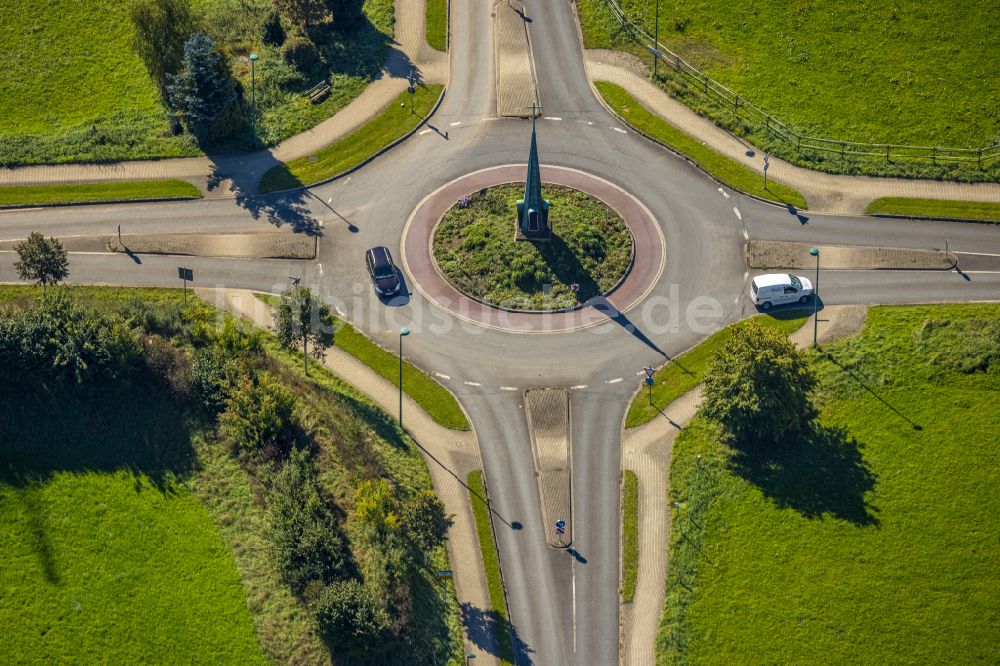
left=219, top=373, right=297, bottom=460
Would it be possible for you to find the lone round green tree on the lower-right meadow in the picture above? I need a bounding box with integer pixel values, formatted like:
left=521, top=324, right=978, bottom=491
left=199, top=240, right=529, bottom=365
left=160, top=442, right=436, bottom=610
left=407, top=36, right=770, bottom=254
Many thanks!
left=702, top=322, right=816, bottom=442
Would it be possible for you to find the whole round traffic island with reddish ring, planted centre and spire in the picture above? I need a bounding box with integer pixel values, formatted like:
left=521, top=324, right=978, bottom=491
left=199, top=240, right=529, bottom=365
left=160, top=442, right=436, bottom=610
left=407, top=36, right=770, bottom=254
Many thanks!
left=401, top=165, right=666, bottom=333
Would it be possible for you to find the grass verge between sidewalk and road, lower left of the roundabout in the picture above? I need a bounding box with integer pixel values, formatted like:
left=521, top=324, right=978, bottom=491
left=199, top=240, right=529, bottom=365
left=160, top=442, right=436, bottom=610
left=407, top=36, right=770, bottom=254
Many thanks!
left=254, top=292, right=469, bottom=430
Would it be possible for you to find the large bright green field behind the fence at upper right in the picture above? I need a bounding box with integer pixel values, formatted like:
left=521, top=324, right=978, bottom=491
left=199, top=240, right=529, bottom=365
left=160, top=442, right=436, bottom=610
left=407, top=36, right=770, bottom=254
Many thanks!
left=577, top=0, right=1000, bottom=148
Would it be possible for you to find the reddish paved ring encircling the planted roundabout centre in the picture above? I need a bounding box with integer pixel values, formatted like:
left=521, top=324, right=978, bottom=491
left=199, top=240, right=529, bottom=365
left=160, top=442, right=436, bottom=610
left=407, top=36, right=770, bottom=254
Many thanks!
left=402, top=164, right=666, bottom=333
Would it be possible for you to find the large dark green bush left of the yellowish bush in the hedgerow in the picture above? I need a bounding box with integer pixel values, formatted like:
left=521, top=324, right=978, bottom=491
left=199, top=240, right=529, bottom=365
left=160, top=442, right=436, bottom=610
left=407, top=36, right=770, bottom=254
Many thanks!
left=267, top=451, right=354, bottom=596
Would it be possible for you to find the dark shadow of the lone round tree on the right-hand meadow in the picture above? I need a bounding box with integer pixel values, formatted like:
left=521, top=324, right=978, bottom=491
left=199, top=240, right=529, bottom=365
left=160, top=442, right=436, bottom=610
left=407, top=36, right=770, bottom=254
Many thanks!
left=730, top=423, right=879, bottom=526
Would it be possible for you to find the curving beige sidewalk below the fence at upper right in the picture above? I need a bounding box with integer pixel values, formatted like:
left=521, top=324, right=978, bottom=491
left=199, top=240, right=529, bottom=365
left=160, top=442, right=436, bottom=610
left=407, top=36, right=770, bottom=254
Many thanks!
left=584, top=49, right=1000, bottom=214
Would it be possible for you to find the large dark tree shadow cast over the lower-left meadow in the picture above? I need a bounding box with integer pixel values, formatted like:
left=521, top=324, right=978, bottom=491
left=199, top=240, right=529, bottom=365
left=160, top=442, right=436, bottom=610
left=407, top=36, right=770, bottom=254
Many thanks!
left=0, top=378, right=196, bottom=585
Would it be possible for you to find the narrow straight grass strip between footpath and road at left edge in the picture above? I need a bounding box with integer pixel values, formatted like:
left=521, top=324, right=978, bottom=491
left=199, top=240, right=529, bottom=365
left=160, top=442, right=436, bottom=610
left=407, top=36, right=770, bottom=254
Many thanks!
left=0, top=180, right=201, bottom=208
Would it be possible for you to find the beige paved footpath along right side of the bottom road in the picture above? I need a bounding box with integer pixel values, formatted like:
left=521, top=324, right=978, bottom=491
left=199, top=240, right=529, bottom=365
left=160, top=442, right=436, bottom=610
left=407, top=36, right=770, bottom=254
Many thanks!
left=621, top=305, right=868, bottom=666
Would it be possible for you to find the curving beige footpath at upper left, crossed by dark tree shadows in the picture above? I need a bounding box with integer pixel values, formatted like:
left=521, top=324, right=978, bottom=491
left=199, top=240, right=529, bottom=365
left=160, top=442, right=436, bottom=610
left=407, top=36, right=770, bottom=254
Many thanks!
left=0, top=0, right=448, bottom=198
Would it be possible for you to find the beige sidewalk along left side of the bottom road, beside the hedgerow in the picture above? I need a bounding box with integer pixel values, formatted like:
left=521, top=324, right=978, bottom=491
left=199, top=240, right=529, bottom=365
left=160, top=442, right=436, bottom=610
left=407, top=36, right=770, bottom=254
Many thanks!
left=194, top=289, right=499, bottom=666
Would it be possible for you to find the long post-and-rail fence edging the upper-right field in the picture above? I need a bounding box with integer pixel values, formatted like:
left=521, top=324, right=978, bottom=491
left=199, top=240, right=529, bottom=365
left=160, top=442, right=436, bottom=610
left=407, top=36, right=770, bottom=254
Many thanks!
left=604, top=0, right=1000, bottom=170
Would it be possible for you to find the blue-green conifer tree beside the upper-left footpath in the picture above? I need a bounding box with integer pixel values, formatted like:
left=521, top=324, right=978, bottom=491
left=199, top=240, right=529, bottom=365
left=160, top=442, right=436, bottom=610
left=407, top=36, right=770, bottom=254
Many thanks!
left=167, top=32, right=239, bottom=137
